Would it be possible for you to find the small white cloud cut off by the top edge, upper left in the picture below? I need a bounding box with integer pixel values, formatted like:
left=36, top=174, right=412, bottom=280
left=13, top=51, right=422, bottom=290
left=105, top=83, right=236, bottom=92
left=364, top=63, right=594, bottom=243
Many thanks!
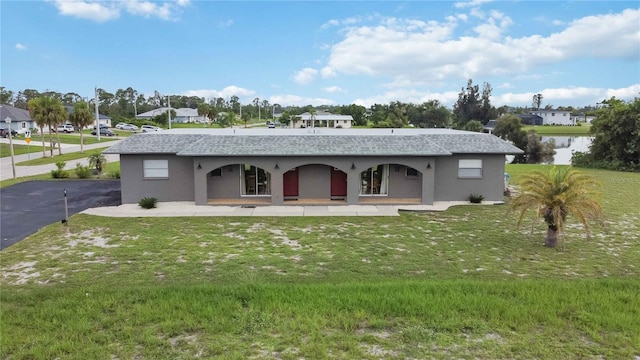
left=54, top=0, right=190, bottom=22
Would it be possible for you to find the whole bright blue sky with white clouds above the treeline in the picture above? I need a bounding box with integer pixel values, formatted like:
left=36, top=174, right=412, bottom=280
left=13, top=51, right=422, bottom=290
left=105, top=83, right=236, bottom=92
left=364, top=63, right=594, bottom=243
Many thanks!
left=0, top=0, right=640, bottom=106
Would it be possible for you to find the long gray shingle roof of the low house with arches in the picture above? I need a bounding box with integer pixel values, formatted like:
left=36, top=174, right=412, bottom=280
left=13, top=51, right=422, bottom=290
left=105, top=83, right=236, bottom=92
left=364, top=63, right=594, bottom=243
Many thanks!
left=105, top=129, right=522, bottom=156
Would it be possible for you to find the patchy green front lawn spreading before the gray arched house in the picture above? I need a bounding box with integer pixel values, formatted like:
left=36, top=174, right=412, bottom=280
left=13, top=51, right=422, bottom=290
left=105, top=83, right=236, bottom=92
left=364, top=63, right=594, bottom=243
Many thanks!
left=0, top=165, right=640, bottom=359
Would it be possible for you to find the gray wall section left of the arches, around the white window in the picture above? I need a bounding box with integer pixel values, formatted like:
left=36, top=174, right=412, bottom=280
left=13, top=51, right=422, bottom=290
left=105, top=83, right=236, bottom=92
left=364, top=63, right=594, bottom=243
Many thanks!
left=120, top=154, right=194, bottom=204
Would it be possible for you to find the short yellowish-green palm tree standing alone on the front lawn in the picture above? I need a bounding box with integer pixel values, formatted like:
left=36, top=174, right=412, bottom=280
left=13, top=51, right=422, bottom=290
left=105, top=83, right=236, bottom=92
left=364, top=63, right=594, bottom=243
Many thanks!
left=511, top=166, right=603, bottom=247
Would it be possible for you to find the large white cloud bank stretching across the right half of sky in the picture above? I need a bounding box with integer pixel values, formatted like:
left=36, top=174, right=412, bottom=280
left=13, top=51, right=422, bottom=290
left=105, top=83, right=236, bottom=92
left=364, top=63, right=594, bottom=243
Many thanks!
left=321, top=9, right=640, bottom=86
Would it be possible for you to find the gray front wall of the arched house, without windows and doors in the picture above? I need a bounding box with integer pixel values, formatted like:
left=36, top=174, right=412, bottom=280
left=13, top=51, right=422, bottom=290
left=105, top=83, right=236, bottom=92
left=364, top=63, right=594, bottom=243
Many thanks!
left=120, top=155, right=505, bottom=205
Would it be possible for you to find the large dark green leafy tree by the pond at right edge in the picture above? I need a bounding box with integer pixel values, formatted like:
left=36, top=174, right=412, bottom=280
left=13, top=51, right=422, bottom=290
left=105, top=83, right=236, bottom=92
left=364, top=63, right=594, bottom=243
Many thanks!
left=589, top=97, right=640, bottom=170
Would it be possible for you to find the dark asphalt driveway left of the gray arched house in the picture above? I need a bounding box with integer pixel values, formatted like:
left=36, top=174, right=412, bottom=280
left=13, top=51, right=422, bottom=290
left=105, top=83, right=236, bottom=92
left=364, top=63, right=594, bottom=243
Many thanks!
left=0, top=180, right=121, bottom=249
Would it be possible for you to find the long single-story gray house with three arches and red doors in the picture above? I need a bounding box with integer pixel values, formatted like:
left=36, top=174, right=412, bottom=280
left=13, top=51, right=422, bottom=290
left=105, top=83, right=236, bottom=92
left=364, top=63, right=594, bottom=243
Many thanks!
left=104, top=128, right=522, bottom=205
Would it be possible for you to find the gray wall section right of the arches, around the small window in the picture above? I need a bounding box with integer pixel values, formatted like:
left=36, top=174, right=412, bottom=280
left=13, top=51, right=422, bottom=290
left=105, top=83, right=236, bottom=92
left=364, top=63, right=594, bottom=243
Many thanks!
left=435, top=154, right=505, bottom=201
